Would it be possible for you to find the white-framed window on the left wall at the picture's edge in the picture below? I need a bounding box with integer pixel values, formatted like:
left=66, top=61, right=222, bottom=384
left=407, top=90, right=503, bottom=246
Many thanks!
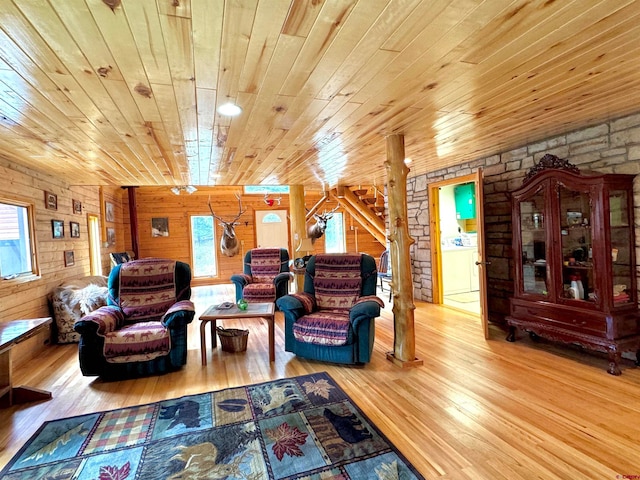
left=0, top=199, right=37, bottom=278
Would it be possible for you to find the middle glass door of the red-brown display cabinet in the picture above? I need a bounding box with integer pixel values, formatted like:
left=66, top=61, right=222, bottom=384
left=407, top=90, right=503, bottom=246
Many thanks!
left=559, top=185, right=598, bottom=303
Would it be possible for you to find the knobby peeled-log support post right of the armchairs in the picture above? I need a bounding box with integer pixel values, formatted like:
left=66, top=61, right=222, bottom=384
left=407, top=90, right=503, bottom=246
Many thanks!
left=384, top=135, right=423, bottom=367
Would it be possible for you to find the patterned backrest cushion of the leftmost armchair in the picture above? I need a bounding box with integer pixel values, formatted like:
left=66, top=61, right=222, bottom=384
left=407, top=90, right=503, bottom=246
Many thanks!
left=119, top=258, right=176, bottom=322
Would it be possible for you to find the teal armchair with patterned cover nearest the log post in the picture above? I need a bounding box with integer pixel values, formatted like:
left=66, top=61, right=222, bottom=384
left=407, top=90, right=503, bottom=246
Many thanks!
left=276, top=254, right=384, bottom=364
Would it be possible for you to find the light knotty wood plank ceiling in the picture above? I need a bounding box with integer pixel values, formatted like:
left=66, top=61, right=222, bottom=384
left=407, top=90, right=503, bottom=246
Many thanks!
left=0, top=0, right=640, bottom=188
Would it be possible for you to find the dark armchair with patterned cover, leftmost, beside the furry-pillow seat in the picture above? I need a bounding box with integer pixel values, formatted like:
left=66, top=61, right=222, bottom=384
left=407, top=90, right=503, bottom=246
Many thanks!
left=74, top=258, right=195, bottom=379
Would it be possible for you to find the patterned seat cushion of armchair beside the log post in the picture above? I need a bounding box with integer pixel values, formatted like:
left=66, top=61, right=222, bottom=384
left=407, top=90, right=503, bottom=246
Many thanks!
left=293, top=310, right=353, bottom=347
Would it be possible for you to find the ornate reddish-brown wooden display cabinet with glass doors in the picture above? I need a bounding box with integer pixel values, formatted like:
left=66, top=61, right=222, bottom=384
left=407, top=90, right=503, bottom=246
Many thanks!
left=506, top=154, right=640, bottom=375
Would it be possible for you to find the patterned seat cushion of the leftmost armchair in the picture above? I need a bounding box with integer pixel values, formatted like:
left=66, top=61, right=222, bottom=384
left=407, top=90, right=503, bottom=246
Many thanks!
left=104, top=322, right=171, bottom=363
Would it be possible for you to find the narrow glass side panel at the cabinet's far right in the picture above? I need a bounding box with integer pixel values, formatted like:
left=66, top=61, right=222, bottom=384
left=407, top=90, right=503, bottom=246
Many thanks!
left=609, top=190, right=633, bottom=305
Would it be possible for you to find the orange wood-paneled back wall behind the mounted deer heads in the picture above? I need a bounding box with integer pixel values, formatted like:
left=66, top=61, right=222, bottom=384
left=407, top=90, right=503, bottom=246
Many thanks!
left=123, top=187, right=384, bottom=284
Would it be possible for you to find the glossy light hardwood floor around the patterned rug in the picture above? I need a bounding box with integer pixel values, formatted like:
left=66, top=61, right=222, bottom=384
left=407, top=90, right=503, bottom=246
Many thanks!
left=0, top=287, right=640, bottom=480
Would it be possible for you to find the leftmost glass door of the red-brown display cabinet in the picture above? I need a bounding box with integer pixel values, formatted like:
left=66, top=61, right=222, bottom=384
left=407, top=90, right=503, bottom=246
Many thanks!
left=520, top=191, right=549, bottom=296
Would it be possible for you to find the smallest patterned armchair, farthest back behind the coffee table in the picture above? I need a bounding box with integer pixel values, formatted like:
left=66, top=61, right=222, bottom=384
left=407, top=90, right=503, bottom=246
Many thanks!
left=231, top=248, right=291, bottom=302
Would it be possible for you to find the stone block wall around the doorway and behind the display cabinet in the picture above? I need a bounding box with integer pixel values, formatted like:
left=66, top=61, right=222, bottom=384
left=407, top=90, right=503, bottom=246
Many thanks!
left=407, top=110, right=640, bottom=323
